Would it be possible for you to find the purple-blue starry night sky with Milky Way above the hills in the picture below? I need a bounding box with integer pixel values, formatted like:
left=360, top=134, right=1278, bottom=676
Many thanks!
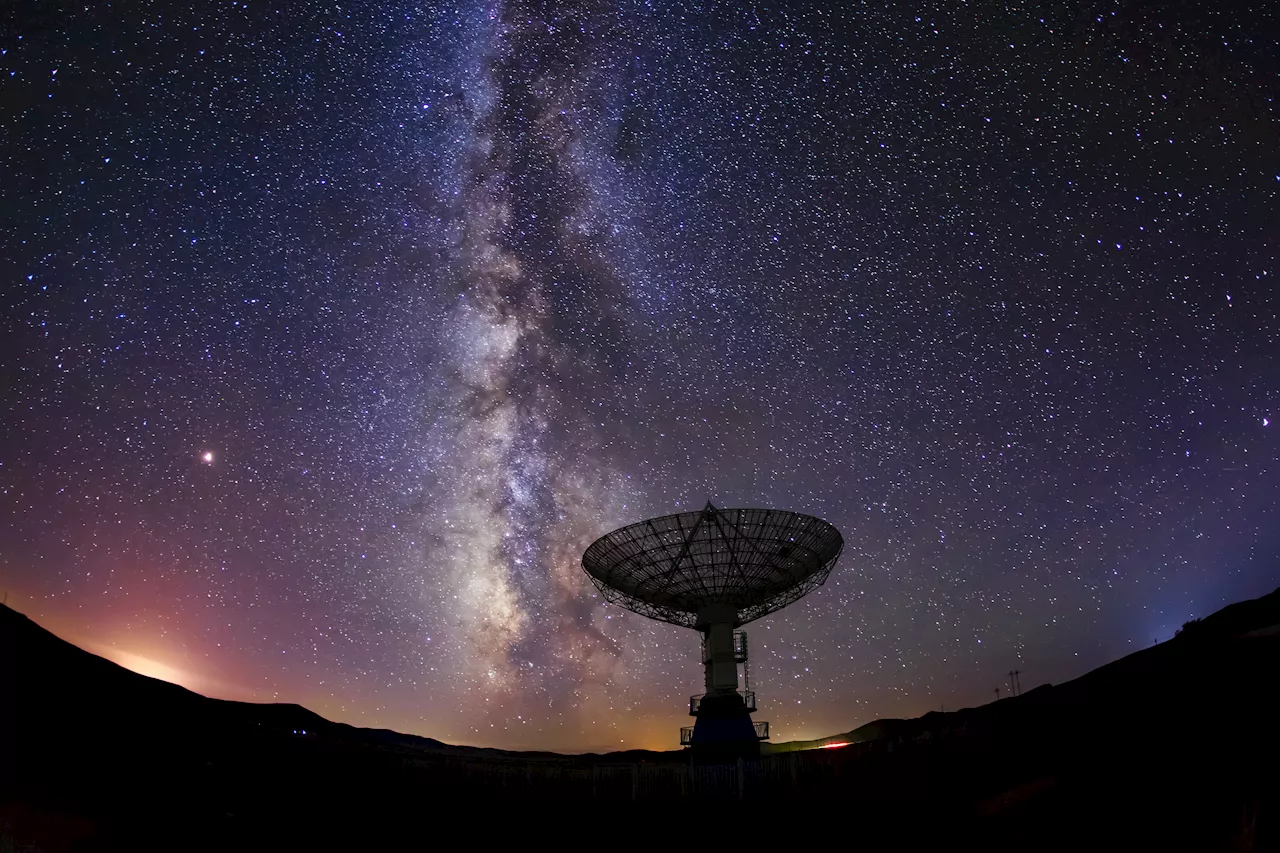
left=0, top=0, right=1280, bottom=751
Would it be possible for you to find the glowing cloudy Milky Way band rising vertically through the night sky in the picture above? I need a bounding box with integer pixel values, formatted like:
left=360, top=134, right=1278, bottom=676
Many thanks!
left=426, top=5, right=645, bottom=707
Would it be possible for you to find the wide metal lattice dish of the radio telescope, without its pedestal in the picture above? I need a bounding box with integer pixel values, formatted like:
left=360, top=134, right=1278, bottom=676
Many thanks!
left=582, top=503, right=845, bottom=628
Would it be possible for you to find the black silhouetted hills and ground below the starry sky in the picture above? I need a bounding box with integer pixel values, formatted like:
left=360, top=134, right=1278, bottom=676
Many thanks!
left=0, top=590, right=1280, bottom=853
